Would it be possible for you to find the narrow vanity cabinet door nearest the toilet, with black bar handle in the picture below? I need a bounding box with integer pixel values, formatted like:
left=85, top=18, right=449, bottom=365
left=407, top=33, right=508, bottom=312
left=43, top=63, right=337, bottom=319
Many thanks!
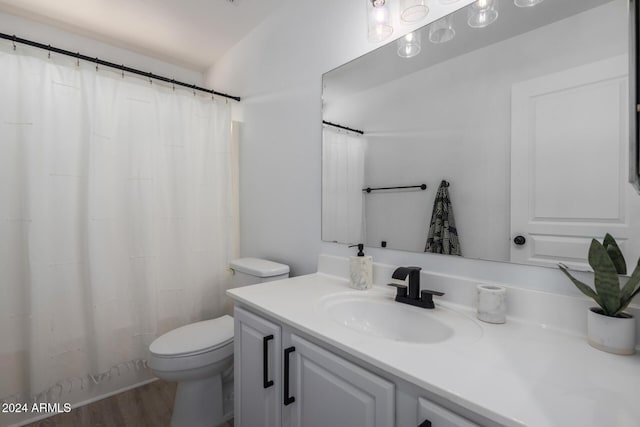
left=233, top=307, right=282, bottom=427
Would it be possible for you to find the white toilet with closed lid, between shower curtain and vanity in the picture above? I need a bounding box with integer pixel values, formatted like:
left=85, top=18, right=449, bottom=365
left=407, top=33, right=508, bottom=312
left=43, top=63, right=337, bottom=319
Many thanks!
left=148, top=258, right=289, bottom=427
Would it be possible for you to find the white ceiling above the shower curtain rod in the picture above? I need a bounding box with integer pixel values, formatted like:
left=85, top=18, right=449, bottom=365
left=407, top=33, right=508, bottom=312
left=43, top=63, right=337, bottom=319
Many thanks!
left=0, top=0, right=284, bottom=71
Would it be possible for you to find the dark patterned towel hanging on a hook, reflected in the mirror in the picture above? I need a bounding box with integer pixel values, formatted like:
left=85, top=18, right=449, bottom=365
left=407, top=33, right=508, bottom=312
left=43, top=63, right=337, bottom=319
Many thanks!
left=424, top=180, right=462, bottom=255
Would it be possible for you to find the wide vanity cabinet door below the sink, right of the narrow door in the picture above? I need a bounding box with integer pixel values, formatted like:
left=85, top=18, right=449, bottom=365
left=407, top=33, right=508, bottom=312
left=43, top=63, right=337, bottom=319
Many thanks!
left=283, top=334, right=395, bottom=427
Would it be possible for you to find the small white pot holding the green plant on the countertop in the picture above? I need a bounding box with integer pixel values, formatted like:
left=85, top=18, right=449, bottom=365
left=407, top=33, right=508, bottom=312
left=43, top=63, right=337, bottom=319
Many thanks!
left=587, top=307, right=636, bottom=355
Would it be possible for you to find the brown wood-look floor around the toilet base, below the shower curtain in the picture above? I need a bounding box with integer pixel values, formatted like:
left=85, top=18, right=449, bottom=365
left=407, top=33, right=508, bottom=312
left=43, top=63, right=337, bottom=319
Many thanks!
left=25, top=380, right=233, bottom=427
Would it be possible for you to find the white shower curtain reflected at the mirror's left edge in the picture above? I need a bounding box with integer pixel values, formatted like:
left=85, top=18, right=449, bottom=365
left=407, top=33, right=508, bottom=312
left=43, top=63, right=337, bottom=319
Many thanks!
left=322, top=127, right=366, bottom=243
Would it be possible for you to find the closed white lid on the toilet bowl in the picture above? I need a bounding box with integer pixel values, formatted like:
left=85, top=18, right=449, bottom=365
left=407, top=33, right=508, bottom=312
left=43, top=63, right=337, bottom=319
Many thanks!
left=149, top=315, right=233, bottom=357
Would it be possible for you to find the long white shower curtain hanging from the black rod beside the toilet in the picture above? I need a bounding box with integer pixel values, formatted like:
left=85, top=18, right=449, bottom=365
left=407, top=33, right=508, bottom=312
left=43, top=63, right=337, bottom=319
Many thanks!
left=0, top=44, right=237, bottom=408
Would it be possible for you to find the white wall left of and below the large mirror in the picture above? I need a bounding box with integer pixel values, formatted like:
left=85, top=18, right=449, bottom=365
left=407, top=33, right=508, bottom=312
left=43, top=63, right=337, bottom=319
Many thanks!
left=207, top=0, right=636, bottom=294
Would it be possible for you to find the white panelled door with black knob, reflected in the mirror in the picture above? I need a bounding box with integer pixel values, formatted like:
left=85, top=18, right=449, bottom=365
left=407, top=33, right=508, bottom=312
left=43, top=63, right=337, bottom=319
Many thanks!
left=511, top=55, right=640, bottom=269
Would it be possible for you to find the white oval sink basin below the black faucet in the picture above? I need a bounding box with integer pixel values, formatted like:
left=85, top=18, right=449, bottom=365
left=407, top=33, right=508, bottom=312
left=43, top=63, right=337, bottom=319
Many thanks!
left=318, top=290, right=482, bottom=344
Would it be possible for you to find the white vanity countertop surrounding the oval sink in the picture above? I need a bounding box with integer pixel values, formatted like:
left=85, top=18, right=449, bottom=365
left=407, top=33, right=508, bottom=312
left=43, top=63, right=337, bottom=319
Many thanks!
left=227, top=273, right=640, bottom=427
